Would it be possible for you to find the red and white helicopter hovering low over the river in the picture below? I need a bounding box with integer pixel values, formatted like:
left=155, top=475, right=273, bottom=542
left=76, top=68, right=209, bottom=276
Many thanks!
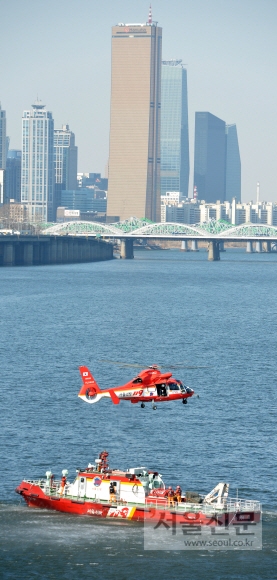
left=78, top=365, right=195, bottom=410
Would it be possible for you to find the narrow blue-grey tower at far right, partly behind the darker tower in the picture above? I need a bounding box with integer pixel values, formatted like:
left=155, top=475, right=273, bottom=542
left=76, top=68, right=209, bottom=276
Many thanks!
left=225, top=125, right=241, bottom=201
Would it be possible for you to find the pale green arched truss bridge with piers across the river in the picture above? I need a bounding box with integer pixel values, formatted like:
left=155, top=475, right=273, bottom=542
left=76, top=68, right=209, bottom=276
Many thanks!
left=42, top=218, right=277, bottom=261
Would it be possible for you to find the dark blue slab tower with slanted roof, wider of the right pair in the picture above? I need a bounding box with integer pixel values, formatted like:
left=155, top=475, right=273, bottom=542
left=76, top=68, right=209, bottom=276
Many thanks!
left=194, top=112, right=226, bottom=203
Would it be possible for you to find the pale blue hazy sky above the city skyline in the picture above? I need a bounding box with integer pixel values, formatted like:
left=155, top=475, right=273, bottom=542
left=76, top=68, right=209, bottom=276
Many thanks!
left=0, top=0, right=277, bottom=201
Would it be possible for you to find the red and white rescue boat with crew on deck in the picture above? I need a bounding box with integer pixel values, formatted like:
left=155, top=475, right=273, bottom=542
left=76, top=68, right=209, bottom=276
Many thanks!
left=15, top=451, right=261, bottom=526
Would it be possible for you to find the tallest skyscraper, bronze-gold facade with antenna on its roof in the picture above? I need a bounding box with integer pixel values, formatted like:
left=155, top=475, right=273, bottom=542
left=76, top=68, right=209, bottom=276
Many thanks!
left=107, top=12, right=162, bottom=221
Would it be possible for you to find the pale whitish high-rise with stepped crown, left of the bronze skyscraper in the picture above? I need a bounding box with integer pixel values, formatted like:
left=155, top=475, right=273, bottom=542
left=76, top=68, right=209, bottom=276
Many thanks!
left=21, top=101, right=54, bottom=222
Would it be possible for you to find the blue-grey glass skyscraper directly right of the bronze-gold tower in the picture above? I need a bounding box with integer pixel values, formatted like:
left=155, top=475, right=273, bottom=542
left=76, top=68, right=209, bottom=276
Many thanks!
left=161, top=60, right=189, bottom=197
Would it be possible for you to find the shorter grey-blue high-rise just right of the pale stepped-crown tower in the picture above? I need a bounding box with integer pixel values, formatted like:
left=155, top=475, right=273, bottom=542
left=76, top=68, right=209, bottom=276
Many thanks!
left=54, top=125, right=78, bottom=219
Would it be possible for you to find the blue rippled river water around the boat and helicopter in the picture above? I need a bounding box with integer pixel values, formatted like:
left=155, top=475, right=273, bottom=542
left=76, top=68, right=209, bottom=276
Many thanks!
left=0, top=249, right=277, bottom=580
